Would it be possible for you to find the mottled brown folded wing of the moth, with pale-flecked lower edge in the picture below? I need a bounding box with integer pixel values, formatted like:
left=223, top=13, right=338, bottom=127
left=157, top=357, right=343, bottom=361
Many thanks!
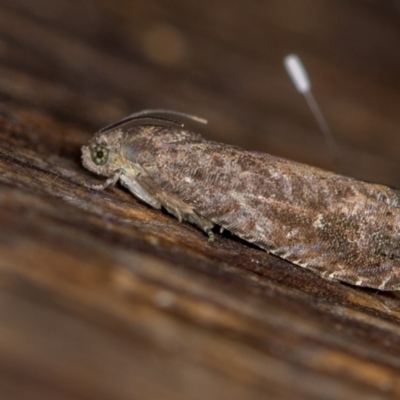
left=142, top=141, right=400, bottom=290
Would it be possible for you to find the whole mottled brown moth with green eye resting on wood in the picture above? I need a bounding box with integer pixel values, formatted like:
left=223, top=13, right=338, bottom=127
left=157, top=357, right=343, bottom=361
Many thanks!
left=82, top=110, right=400, bottom=290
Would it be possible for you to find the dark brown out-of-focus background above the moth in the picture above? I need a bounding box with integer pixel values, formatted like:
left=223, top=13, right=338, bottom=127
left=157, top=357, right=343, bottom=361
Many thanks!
left=0, top=0, right=400, bottom=186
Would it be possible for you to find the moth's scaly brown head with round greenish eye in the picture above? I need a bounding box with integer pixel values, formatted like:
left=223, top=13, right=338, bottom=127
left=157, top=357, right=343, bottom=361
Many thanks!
left=82, top=131, right=122, bottom=176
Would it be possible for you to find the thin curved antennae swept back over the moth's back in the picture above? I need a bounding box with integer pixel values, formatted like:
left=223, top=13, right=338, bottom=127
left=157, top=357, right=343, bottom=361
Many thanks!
left=99, top=109, right=207, bottom=133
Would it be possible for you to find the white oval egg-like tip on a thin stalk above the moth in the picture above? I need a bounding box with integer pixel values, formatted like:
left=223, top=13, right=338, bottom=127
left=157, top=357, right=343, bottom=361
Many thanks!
left=284, top=54, right=339, bottom=165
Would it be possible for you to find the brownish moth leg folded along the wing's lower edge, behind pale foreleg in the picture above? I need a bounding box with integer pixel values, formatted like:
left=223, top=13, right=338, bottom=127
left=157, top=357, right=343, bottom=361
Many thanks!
left=136, top=173, right=214, bottom=234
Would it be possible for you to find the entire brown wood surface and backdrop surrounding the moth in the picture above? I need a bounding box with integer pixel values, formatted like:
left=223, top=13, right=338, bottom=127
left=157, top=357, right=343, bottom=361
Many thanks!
left=0, top=0, right=400, bottom=400
